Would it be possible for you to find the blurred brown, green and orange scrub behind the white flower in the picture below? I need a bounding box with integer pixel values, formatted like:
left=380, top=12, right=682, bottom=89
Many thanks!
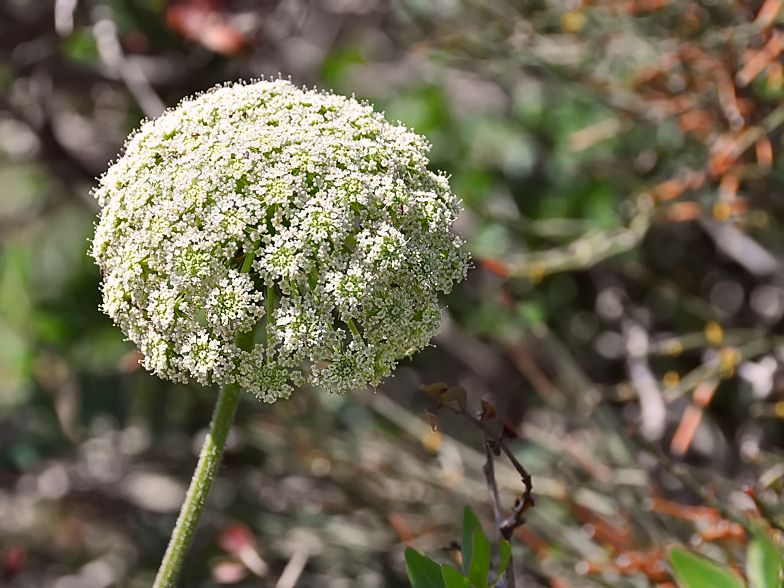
left=0, top=0, right=784, bottom=588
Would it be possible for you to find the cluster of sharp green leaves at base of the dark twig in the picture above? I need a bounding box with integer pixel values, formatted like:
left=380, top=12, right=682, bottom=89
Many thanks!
left=406, top=506, right=512, bottom=588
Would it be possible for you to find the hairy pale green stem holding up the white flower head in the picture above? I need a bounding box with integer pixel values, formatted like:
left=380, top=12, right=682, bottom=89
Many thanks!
left=153, top=329, right=254, bottom=588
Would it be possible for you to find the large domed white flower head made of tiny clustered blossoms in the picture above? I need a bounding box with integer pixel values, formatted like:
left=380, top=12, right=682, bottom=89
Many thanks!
left=92, top=80, right=467, bottom=401
